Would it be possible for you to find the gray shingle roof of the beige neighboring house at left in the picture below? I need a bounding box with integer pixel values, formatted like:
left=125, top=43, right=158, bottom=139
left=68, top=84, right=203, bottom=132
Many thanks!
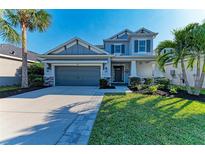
left=0, top=44, right=37, bottom=61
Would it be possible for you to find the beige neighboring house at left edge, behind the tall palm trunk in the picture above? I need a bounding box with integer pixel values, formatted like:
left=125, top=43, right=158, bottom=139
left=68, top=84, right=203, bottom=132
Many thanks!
left=0, top=44, right=37, bottom=86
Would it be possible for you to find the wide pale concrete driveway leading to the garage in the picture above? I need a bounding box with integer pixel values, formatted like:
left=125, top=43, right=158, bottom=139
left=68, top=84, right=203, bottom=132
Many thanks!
left=0, top=87, right=103, bottom=145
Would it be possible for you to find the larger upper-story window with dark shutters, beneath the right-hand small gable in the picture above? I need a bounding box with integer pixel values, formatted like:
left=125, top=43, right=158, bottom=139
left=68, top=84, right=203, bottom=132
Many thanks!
left=134, top=40, right=151, bottom=52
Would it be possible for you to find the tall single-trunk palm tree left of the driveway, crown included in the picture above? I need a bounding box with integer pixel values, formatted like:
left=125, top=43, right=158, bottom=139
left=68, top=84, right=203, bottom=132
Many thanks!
left=0, top=9, right=51, bottom=88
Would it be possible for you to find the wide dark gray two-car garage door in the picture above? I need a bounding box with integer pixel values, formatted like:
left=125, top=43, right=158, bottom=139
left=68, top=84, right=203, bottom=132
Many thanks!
left=55, top=66, right=100, bottom=86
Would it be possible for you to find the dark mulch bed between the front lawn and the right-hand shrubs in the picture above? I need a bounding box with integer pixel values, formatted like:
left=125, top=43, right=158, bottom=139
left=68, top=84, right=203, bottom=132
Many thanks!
left=130, top=89, right=205, bottom=102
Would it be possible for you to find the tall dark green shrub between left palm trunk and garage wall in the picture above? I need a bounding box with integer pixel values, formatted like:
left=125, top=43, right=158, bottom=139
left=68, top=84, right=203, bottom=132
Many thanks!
left=28, top=63, right=44, bottom=87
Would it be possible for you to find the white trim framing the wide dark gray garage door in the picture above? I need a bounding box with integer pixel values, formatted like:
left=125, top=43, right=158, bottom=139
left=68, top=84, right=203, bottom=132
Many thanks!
left=51, top=64, right=103, bottom=86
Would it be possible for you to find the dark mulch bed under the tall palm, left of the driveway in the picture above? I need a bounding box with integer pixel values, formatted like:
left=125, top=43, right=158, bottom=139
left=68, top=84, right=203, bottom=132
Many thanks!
left=0, top=87, right=46, bottom=98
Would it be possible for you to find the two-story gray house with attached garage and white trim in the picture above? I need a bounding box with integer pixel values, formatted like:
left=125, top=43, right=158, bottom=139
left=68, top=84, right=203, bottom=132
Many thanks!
left=40, top=28, right=161, bottom=86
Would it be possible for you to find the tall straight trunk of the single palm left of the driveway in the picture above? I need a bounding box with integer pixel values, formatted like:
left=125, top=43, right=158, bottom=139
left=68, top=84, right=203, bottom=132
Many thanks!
left=21, top=24, right=28, bottom=88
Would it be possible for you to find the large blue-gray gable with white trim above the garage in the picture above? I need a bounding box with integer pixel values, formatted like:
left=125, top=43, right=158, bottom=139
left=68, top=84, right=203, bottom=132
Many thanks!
left=47, top=38, right=109, bottom=55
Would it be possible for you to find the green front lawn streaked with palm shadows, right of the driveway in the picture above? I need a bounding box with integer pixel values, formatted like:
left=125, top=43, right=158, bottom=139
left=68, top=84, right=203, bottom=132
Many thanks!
left=89, top=93, right=205, bottom=144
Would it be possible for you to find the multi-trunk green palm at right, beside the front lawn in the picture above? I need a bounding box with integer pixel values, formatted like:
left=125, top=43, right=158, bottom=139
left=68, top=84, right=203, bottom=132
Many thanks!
left=157, top=23, right=202, bottom=94
